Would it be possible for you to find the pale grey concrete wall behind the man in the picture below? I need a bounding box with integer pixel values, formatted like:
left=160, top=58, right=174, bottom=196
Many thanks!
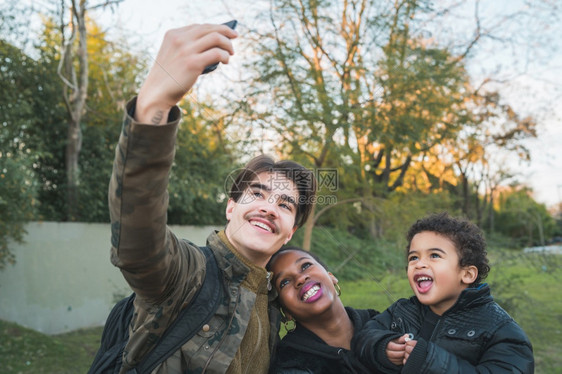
left=0, top=222, right=219, bottom=334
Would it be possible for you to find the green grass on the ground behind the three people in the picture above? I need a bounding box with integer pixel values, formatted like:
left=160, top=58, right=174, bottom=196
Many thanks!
left=0, top=251, right=562, bottom=374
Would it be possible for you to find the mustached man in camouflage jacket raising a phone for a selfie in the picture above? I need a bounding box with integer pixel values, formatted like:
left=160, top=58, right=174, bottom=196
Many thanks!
left=105, top=25, right=316, bottom=373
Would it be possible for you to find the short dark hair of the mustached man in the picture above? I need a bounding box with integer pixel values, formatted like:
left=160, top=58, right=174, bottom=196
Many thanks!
left=229, top=155, right=316, bottom=227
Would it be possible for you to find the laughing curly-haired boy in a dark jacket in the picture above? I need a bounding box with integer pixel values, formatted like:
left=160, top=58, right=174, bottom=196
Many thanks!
left=352, top=213, right=534, bottom=374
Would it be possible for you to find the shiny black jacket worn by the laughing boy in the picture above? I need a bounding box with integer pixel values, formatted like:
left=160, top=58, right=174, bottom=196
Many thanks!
left=351, top=284, right=534, bottom=374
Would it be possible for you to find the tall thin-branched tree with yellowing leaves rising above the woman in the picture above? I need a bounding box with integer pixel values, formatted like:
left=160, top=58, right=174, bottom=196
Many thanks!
left=234, top=0, right=467, bottom=248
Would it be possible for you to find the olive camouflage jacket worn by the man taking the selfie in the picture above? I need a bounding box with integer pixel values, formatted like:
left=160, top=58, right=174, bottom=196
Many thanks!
left=109, top=99, right=280, bottom=374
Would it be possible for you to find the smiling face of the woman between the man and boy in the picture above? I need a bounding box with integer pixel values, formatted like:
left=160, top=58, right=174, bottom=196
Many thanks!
left=270, top=250, right=338, bottom=322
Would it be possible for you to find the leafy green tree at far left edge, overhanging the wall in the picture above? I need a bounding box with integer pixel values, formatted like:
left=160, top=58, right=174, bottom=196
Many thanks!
left=0, top=40, right=49, bottom=269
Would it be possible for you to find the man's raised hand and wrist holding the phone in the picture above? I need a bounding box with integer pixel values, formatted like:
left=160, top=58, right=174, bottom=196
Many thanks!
left=135, top=24, right=238, bottom=125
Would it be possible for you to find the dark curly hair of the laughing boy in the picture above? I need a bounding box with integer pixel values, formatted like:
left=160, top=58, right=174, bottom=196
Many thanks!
left=406, top=212, right=490, bottom=284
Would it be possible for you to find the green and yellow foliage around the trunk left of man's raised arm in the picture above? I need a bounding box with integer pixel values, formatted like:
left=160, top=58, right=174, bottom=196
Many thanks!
left=0, top=13, right=149, bottom=268
